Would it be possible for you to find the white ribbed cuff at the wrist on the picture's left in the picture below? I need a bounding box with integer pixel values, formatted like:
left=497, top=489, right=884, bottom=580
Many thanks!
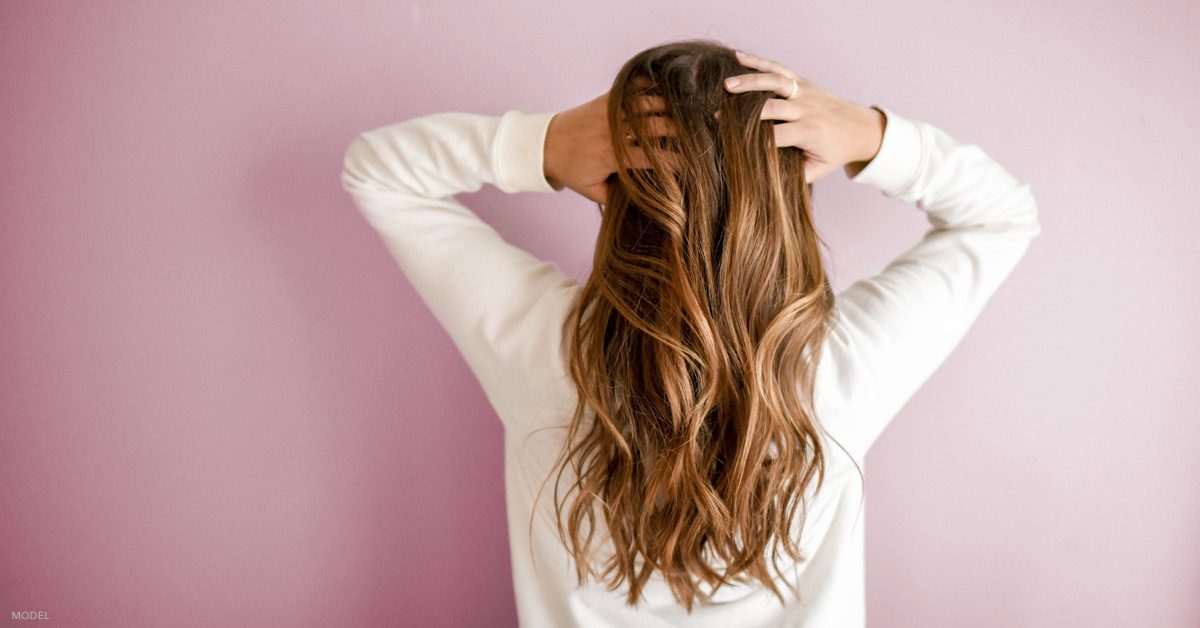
left=492, top=109, right=558, bottom=193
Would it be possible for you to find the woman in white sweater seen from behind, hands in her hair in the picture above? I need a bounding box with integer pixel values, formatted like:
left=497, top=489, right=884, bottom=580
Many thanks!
left=342, top=40, right=1040, bottom=627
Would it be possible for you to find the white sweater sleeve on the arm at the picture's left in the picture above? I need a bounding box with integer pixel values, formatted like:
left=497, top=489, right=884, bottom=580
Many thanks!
left=341, top=110, right=577, bottom=425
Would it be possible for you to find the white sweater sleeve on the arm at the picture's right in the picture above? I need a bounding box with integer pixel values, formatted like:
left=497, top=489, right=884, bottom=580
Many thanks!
left=817, top=107, right=1040, bottom=455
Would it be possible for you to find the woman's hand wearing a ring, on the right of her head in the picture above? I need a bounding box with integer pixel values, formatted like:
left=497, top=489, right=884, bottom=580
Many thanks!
left=725, top=52, right=887, bottom=183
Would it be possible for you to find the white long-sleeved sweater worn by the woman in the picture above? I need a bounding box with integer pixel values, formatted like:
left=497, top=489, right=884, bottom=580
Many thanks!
left=342, top=102, right=1040, bottom=628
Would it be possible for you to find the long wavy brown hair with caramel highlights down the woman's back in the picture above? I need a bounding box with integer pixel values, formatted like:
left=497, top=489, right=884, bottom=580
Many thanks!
left=539, top=40, right=857, bottom=612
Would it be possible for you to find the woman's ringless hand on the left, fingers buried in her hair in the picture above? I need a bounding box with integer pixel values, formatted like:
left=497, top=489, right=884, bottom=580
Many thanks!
left=542, top=91, right=673, bottom=203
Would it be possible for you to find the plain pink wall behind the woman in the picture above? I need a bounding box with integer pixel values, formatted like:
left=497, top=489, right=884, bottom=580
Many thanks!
left=0, top=0, right=1200, bottom=628
